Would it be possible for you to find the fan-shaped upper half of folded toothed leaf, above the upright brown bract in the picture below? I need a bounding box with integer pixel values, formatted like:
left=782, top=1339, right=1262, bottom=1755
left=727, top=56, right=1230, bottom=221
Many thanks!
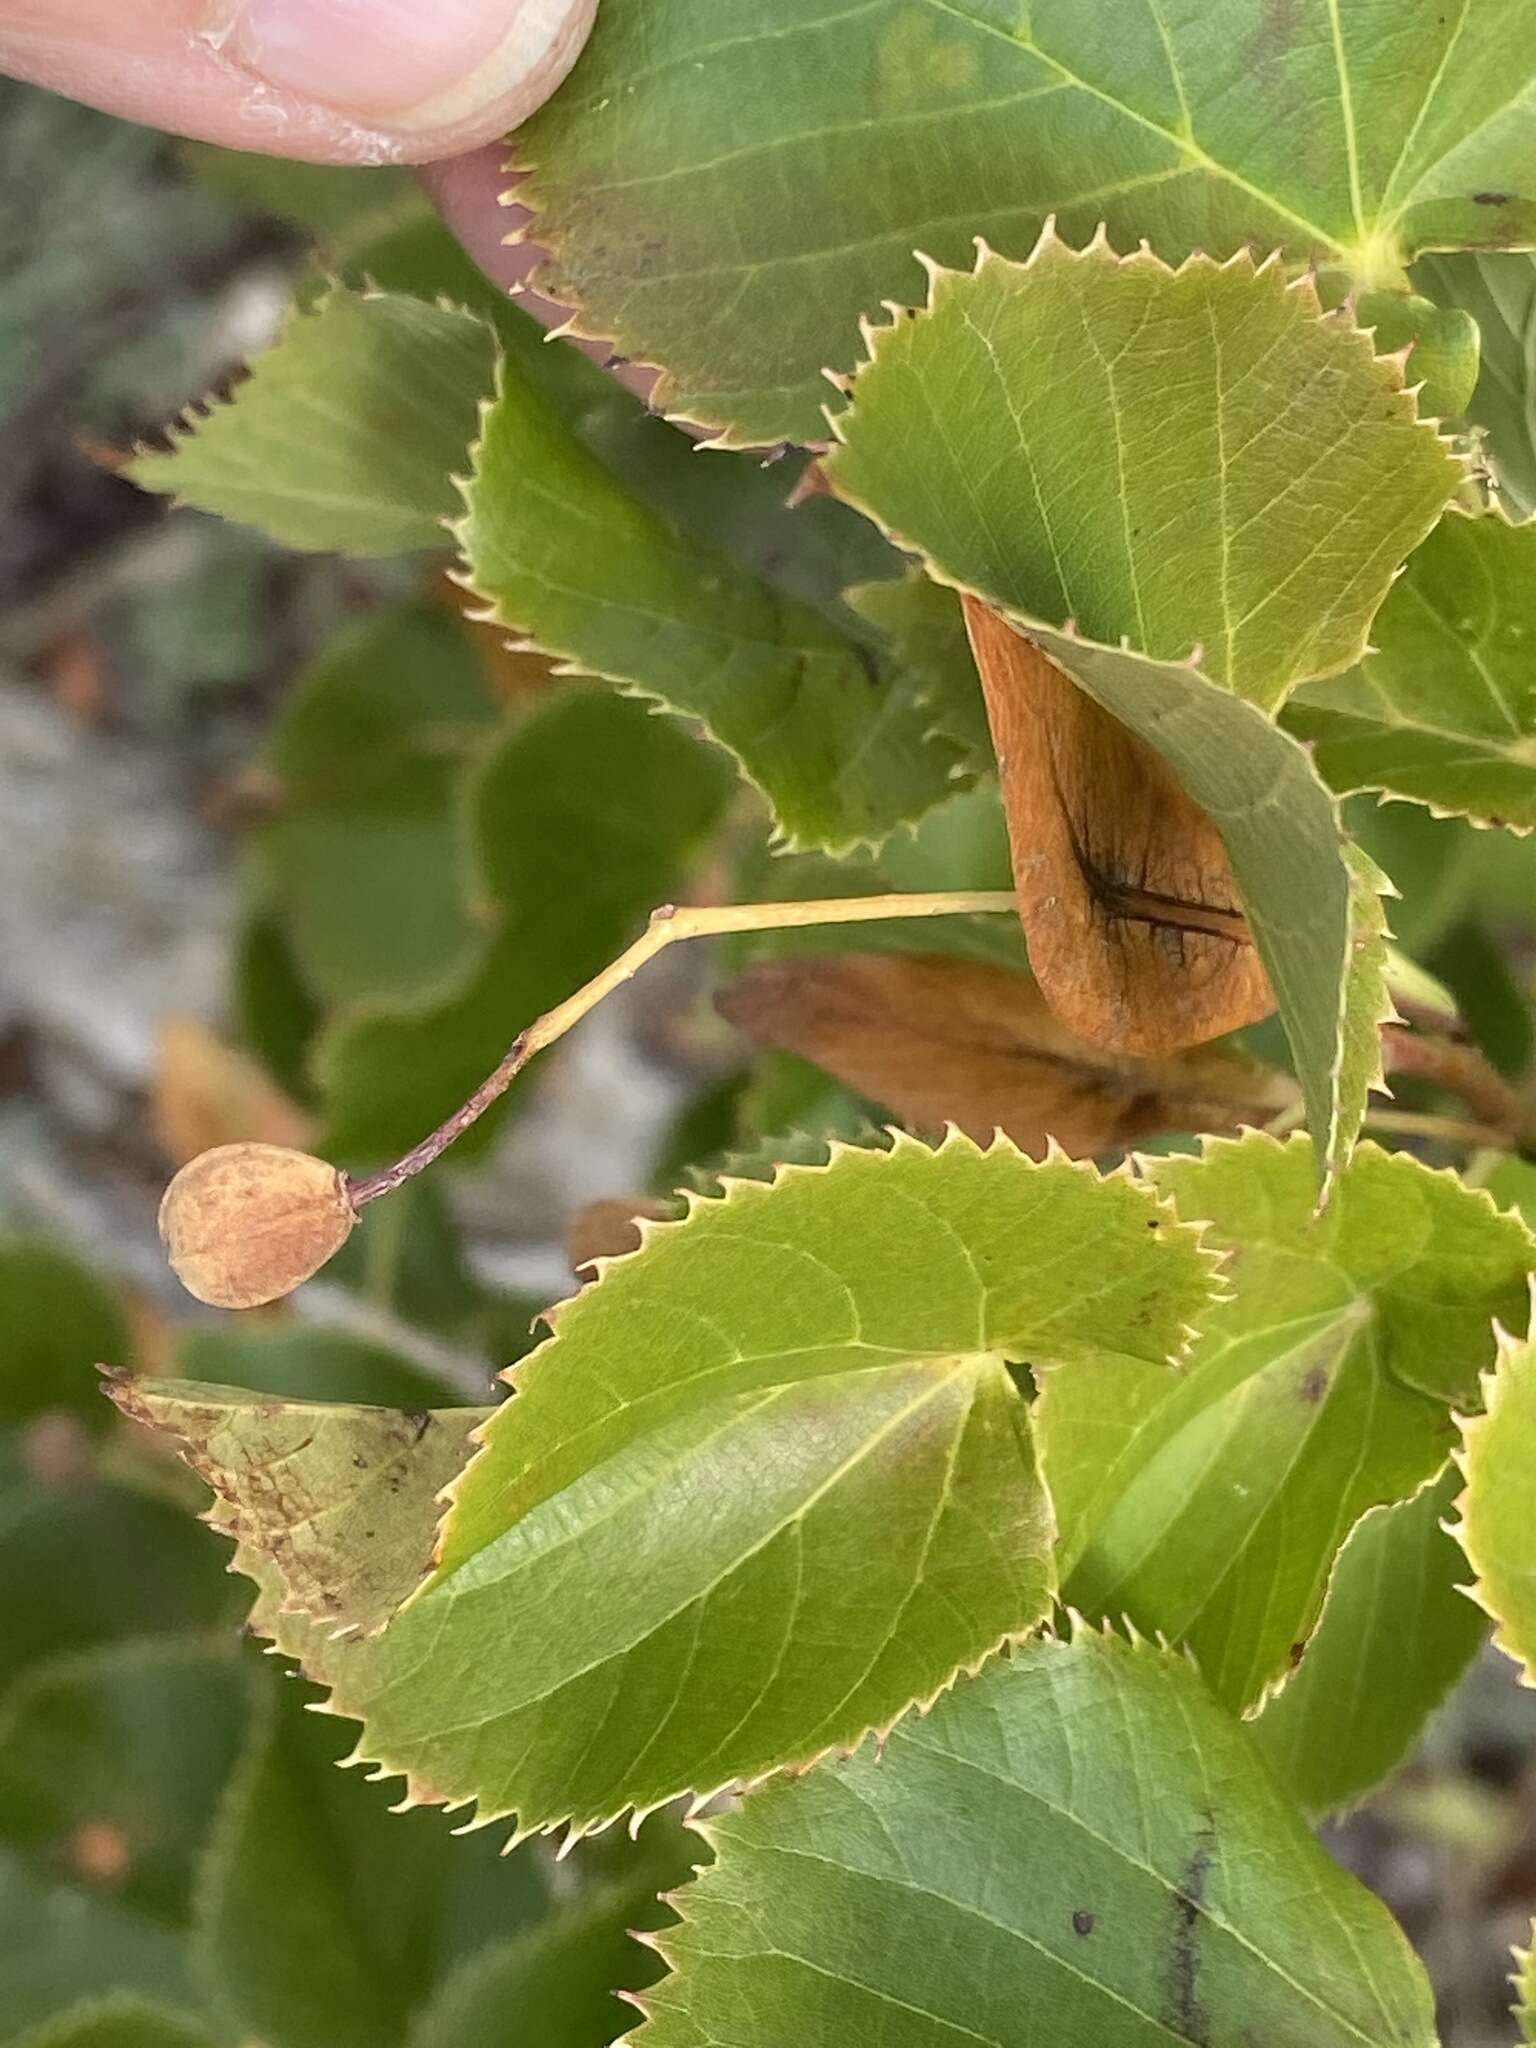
left=825, top=233, right=1462, bottom=711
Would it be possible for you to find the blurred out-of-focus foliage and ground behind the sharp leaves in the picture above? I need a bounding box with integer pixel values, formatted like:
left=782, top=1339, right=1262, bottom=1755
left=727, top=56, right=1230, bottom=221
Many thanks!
left=0, top=75, right=1536, bottom=2048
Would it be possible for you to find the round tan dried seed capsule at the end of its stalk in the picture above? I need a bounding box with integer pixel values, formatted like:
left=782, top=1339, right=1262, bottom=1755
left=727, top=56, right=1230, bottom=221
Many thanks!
left=160, top=1145, right=356, bottom=1309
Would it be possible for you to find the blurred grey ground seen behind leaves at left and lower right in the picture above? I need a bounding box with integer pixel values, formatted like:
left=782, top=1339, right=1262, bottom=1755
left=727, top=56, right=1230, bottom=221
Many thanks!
left=0, top=72, right=1536, bottom=2048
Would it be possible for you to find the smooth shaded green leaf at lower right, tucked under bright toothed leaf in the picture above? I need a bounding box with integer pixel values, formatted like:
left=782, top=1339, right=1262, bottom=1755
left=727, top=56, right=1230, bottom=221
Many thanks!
left=1251, top=1470, right=1487, bottom=1815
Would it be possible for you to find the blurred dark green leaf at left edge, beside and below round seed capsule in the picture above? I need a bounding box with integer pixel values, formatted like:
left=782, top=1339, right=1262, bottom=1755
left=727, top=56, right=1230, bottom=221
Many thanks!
left=0, top=1237, right=129, bottom=1434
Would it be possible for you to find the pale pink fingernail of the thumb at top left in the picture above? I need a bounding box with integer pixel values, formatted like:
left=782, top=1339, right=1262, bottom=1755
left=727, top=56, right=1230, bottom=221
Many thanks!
left=225, top=0, right=596, bottom=131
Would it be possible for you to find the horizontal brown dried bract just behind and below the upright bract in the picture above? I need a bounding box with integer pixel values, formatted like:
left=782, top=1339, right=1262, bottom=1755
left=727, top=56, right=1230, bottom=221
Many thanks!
left=719, top=952, right=1296, bottom=1157
